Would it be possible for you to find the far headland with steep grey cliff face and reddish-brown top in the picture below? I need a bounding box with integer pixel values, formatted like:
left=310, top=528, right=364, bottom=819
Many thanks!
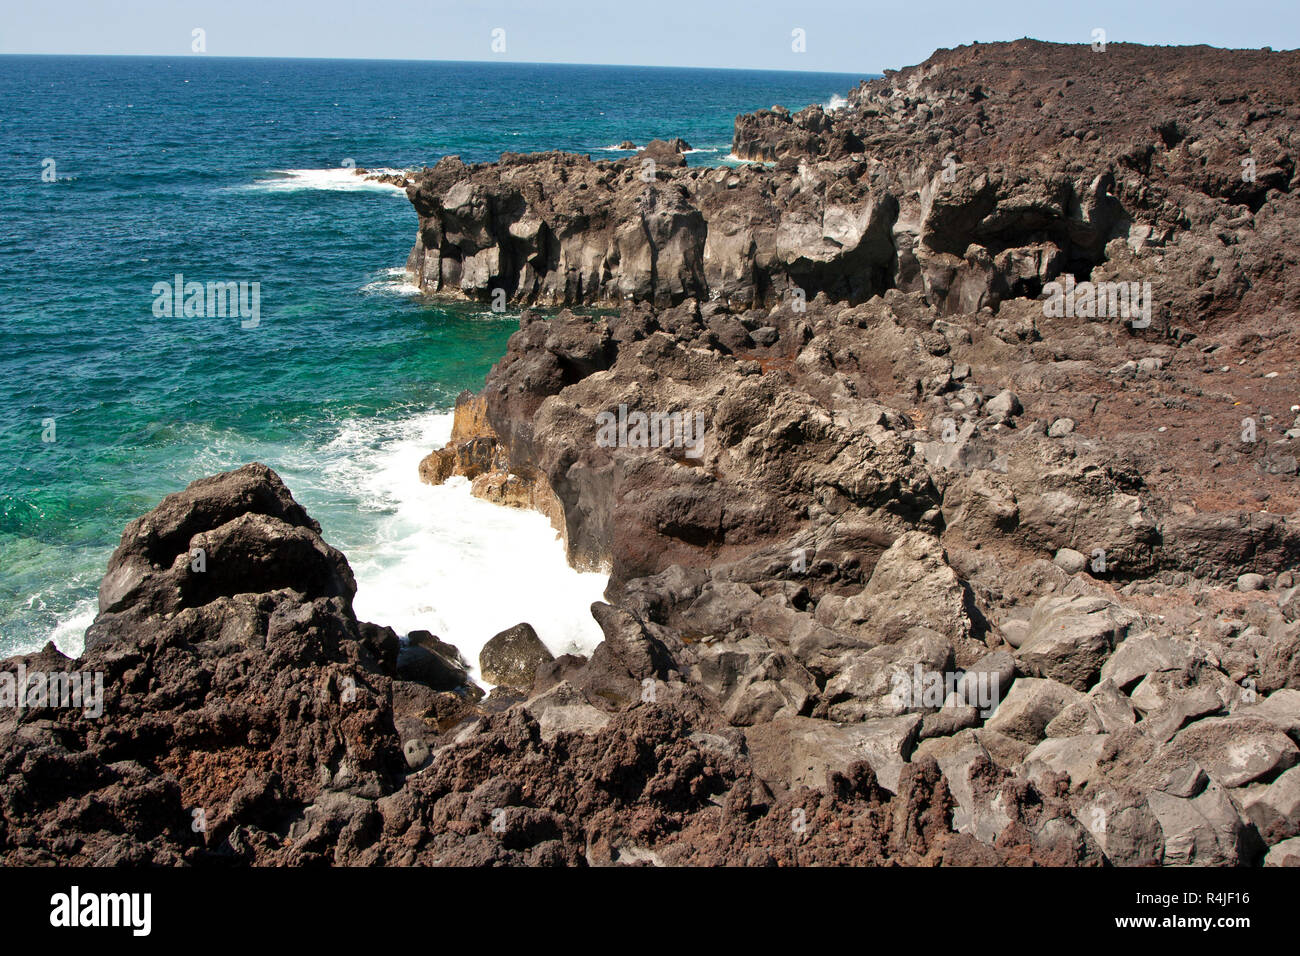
left=408, top=40, right=1300, bottom=324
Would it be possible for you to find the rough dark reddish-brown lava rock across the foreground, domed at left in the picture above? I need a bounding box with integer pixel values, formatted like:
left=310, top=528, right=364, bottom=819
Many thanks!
left=0, top=466, right=1086, bottom=865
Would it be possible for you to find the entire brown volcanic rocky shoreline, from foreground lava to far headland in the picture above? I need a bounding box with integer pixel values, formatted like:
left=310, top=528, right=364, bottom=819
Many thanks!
left=0, top=40, right=1300, bottom=866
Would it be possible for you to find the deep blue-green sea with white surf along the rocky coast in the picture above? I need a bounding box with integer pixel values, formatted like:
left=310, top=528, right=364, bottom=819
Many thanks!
left=0, top=56, right=872, bottom=671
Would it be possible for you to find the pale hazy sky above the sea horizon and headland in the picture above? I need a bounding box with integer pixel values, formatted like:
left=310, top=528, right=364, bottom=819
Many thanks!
left=0, top=0, right=1300, bottom=73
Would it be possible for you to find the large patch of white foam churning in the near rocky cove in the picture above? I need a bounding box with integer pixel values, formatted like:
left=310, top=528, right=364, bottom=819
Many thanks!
left=308, top=412, right=607, bottom=678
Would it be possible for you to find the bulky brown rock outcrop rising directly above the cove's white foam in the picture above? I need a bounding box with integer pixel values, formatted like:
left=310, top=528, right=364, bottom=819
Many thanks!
left=486, top=303, right=939, bottom=581
